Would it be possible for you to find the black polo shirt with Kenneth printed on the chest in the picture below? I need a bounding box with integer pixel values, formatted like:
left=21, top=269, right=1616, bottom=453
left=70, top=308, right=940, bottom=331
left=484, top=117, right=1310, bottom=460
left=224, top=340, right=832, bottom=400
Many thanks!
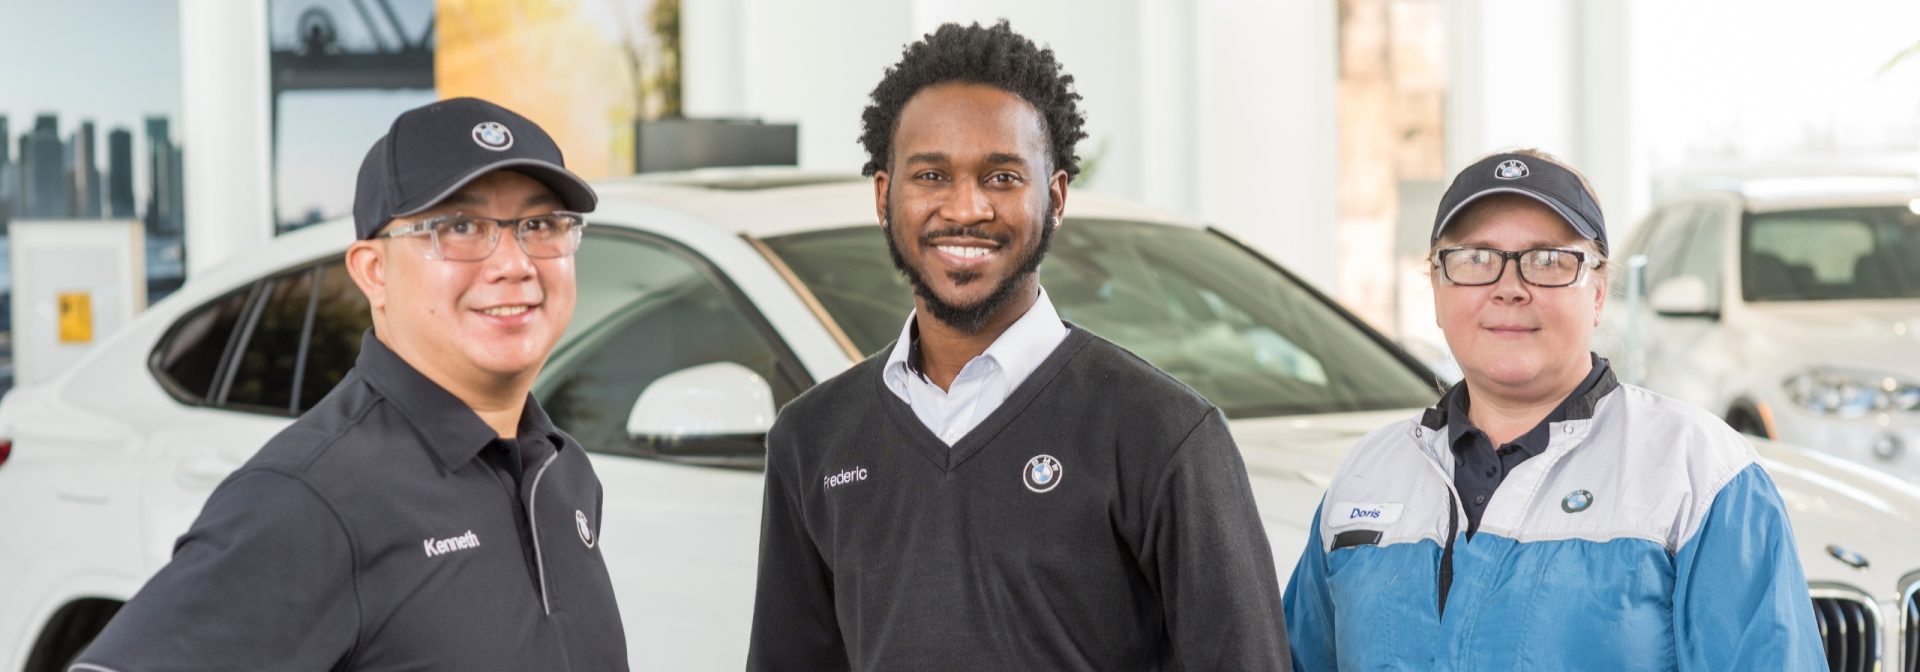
left=75, top=330, right=626, bottom=670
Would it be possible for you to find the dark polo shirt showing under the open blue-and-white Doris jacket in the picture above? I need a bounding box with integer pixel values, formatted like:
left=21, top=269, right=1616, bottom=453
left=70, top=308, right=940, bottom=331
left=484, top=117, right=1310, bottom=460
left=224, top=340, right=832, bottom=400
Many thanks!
left=1440, top=353, right=1613, bottom=538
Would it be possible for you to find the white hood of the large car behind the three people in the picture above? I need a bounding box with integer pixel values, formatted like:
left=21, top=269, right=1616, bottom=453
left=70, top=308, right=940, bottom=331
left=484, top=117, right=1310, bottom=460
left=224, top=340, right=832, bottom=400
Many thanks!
left=1231, top=409, right=1920, bottom=601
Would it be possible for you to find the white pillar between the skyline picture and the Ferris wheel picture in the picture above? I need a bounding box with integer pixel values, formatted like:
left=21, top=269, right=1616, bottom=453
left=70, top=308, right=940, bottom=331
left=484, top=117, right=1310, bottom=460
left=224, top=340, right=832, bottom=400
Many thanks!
left=179, top=0, right=273, bottom=278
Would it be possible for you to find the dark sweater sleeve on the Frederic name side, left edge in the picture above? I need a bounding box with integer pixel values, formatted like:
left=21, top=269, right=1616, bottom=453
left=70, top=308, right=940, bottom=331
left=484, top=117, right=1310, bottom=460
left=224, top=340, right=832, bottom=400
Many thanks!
left=747, top=424, right=852, bottom=670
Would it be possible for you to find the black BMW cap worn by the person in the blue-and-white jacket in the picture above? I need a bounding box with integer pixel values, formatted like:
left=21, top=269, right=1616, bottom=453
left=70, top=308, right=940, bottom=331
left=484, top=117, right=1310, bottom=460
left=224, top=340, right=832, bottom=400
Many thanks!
left=1428, top=154, right=1609, bottom=255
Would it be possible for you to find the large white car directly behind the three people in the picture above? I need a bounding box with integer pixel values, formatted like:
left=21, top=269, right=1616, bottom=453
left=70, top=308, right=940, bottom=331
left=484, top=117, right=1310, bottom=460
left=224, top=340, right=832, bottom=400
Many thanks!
left=0, top=171, right=1920, bottom=672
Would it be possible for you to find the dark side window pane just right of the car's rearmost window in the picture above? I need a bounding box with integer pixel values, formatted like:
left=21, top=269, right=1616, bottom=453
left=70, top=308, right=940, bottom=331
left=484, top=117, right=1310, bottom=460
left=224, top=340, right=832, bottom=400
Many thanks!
left=221, top=267, right=315, bottom=415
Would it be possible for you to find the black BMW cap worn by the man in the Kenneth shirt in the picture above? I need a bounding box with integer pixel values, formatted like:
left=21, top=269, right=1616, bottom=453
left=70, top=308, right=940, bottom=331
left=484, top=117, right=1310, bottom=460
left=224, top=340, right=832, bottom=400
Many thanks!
left=353, top=98, right=599, bottom=240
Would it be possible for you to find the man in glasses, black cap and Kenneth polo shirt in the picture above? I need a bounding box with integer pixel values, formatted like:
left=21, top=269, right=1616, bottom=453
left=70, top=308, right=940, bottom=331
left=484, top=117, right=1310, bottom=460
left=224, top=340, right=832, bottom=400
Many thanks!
left=73, top=98, right=626, bottom=670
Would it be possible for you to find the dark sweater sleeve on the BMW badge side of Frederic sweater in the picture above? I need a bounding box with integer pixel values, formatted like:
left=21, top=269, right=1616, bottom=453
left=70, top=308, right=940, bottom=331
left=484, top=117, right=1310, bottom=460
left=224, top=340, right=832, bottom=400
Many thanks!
left=1142, top=409, right=1290, bottom=670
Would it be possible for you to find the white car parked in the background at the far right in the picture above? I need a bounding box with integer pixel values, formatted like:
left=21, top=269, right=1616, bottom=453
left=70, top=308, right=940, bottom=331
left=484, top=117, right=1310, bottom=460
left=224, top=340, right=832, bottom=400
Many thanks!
left=1607, top=177, right=1920, bottom=484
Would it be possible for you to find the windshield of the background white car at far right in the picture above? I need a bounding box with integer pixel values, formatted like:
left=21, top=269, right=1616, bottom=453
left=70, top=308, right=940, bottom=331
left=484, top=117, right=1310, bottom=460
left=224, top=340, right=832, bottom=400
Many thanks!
left=1740, top=205, right=1920, bottom=301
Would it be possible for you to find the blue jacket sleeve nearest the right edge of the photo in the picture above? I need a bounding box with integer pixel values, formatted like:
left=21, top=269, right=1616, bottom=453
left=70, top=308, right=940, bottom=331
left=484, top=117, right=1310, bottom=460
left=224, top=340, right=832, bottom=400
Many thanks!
left=1666, top=465, right=1826, bottom=672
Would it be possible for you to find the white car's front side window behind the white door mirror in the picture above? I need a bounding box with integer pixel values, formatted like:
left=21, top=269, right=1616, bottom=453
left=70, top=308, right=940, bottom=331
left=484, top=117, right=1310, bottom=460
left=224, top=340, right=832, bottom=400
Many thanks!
left=536, top=232, right=812, bottom=457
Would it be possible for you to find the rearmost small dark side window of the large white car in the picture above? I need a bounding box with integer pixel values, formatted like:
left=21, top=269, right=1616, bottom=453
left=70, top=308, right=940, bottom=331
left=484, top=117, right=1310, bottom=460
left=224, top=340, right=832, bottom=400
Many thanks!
left=150, top=284, right=253, bottom=403
